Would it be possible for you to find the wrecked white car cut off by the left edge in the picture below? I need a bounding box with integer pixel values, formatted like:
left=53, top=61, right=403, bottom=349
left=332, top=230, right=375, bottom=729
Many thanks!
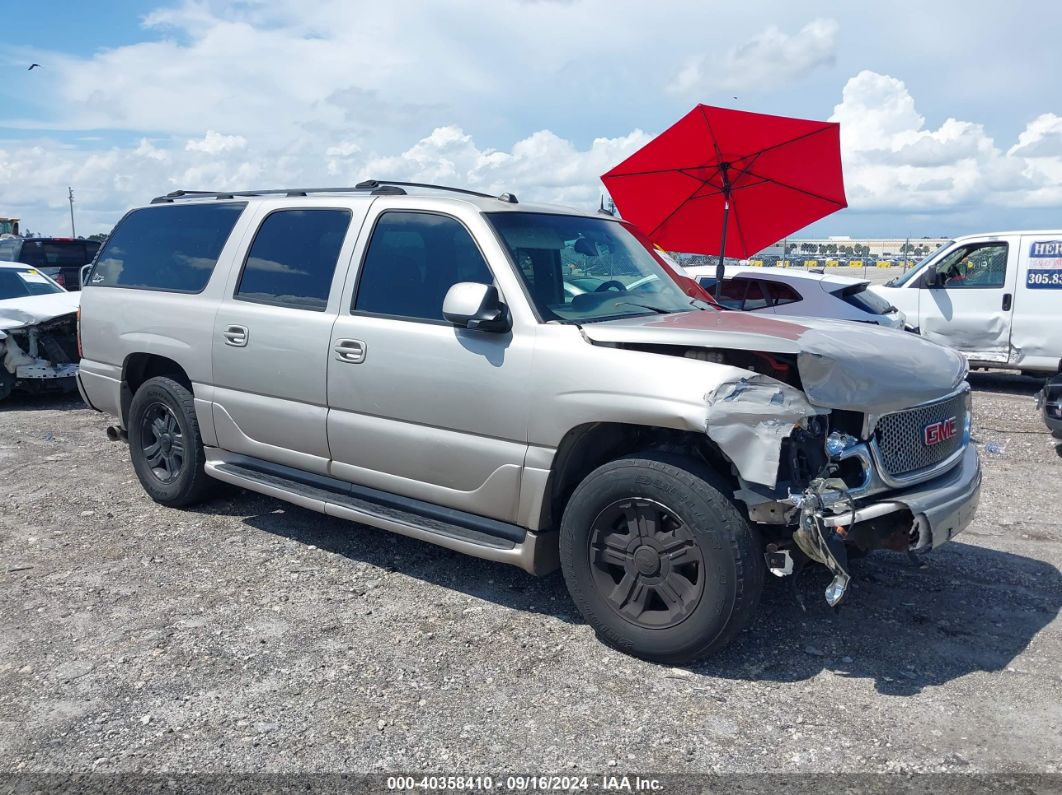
left=0, top=262, right=79, bottom=400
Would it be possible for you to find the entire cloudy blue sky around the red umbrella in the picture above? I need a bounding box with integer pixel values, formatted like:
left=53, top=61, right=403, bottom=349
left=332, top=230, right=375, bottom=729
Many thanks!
left=0, top=0, right=1062, bottom=242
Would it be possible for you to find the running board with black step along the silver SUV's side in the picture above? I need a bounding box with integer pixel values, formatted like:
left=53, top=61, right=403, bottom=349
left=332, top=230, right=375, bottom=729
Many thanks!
left=205, top=448, right=559, bottom=574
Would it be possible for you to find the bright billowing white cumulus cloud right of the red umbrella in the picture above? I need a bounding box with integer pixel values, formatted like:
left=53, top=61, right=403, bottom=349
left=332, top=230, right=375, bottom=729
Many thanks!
left=830, top=70, right=1062, bottom=212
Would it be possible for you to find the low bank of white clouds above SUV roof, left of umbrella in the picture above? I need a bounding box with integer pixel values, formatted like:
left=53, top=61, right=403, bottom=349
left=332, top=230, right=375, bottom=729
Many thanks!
left=0, top=125, right=651, bottom=235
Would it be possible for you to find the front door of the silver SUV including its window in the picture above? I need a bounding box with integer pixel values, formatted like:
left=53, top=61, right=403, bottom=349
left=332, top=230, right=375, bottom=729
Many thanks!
left=328, top=209, right=534, bottom=521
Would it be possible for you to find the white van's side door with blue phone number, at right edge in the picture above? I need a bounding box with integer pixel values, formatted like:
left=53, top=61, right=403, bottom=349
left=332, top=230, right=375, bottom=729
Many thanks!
left=1010, top=232, right=1062, bottom=371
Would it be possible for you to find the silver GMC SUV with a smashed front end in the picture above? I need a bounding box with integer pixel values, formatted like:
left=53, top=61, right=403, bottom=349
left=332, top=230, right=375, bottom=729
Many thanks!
left=79, top=180, right=981, bottom=662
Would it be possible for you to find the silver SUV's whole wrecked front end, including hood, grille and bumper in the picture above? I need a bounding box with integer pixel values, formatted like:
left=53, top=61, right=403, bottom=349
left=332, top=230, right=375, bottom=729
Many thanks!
left=583, top=312, right=981, bottom=605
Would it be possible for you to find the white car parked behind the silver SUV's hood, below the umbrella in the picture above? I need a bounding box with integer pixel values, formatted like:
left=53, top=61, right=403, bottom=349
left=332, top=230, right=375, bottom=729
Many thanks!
left=686, top=265, right=905, bottom=329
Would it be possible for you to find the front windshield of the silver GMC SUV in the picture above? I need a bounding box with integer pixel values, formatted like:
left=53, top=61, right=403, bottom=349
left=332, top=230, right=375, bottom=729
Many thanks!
left=487, top=212, right=705, bottom=323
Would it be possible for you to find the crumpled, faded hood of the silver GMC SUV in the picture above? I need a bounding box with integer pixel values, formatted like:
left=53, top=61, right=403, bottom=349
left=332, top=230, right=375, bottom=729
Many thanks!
left=581, top=310, right=966, bottom=414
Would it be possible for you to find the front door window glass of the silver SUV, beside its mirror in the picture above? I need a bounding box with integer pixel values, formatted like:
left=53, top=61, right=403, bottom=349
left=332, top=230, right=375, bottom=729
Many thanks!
left=352, top=211, right=494, bottom=321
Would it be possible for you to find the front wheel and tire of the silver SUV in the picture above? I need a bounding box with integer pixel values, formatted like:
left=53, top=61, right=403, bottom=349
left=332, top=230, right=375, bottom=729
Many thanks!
left=560, top=452, right=766, bottom=664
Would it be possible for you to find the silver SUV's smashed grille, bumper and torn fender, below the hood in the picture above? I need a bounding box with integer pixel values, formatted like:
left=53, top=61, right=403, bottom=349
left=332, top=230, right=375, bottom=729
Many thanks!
left=706, top=377, right=981, bottom=606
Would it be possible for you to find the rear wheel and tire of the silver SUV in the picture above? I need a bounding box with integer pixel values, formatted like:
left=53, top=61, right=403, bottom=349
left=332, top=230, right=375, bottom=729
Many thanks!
left=127, top=376, right=215, bottom=507
